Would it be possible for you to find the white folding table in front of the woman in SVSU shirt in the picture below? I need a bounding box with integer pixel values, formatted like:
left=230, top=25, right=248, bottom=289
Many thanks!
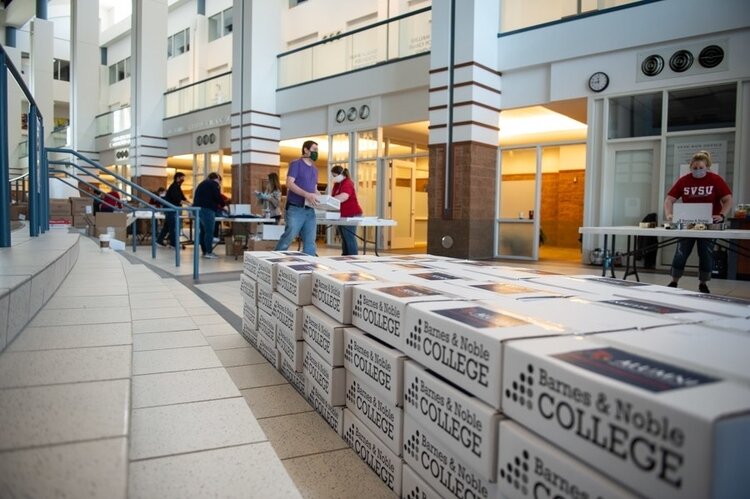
left=578, top=225, right=750, bottom=281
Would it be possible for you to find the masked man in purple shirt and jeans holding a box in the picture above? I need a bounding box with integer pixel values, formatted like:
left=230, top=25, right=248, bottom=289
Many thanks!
left=276, top=140, right=318, bottom=256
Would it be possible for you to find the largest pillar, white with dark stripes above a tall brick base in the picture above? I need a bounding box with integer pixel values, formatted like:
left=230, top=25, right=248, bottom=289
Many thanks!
left=427, top=0, right=500, bottom=259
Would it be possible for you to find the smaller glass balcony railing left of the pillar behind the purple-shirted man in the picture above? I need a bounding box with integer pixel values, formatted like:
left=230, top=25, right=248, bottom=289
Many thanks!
left=164, top=71, right=232, bottom=118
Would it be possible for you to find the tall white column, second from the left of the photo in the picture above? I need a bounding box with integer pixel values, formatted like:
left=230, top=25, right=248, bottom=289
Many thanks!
left=70, top=0, right=101, bottom=161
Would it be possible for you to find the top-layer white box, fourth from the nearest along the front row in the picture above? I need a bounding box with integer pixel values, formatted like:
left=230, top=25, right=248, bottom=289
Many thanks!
left=311, top=270, right=378, bottom=324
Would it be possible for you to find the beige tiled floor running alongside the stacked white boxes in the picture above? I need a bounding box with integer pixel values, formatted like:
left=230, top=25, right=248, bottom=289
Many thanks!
left=0, top=235, right=750, bottom=498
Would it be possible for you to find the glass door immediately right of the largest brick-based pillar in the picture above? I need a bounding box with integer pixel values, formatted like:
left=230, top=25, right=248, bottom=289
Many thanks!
left=496, top=147, right=541, bottom=260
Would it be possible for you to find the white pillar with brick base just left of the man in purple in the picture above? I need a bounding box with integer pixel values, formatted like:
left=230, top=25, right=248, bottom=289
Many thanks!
left=231, top=0, right=285, bottom=203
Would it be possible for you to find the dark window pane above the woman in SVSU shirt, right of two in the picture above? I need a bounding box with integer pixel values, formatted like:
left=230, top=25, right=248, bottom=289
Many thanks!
left=667, top=84, right=737, bottom=132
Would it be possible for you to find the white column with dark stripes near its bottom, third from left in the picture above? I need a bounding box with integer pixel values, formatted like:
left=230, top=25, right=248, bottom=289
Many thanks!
left=129, top=0, right=168, bottom=182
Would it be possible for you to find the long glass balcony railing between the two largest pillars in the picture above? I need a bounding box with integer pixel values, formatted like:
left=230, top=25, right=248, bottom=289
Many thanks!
left=277, top=7, right=432, bottom=89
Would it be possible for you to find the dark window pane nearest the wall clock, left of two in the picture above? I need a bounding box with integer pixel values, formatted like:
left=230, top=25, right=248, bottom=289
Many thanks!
left=609, top=92, right=662, bottom=139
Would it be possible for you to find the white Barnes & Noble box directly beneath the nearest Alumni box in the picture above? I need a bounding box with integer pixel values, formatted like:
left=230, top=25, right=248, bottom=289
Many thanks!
left=498, top=419, right=638, bottom=499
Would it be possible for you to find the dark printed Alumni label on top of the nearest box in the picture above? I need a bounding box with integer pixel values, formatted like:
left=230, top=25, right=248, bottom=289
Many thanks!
left=553, top=348, right=721, bottom=392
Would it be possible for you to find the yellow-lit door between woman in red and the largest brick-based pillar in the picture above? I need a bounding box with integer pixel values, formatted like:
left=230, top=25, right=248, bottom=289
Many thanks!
left=388, top=160, right=416, bottom=249
